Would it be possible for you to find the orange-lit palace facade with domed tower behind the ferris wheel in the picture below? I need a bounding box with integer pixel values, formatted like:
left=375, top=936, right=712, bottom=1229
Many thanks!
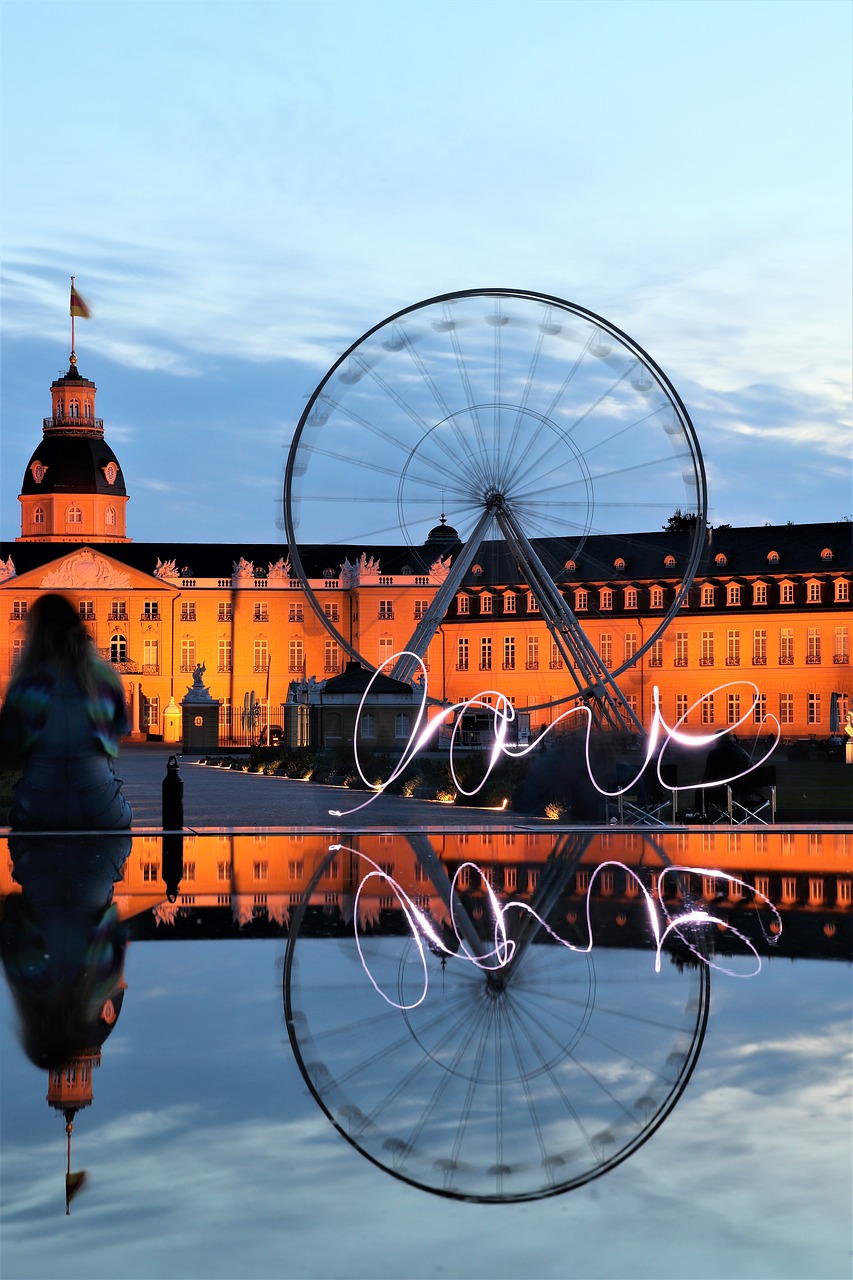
left=0, top=357, right=853, bottom=745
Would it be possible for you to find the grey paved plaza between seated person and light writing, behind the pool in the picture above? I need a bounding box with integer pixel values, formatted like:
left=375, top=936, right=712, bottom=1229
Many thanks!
left=117, top=744, right=525, bottom=831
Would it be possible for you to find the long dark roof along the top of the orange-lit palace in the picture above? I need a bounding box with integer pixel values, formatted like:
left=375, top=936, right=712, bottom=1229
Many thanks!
left=0, top=519, right=853, bottom=586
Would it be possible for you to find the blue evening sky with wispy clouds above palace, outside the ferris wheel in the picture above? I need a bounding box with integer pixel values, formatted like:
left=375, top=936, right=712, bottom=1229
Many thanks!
left=0, top=0, right=853, bottom=541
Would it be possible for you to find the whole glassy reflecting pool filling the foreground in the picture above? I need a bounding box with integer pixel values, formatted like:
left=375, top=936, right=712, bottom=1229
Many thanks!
left=0, top=827, right=853, bottom=1280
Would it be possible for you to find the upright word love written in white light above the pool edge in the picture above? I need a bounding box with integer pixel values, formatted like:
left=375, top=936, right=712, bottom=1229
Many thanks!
left=329, top=650, right=781, bottom=818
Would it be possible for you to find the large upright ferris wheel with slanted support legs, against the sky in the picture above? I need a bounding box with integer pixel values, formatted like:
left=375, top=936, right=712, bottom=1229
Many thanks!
left=284, top=289, right=707, bottom=726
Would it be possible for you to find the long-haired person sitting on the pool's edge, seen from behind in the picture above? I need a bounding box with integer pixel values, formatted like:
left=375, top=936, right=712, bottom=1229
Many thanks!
left=0, top=595, right=132, bottom=831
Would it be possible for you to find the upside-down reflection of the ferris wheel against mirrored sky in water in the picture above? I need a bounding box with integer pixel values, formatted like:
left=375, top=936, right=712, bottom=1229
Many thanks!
left=284, top=849, right=710, bottom=1202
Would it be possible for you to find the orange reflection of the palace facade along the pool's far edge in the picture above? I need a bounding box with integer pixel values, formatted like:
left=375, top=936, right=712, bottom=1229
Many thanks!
left=0, top=828, right=853, bottom=951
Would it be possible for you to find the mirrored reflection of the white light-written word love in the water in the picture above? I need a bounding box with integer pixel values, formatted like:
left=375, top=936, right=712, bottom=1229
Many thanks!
left=329, top=845, right=781, bottom=1010
